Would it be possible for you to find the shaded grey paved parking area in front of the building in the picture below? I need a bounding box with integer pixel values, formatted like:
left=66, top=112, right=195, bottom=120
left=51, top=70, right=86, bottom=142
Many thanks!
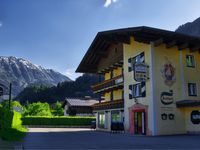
left=7, top=128, right=200, bottom=149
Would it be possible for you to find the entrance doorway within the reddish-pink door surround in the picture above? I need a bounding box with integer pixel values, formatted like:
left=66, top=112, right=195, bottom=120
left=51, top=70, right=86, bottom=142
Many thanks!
left=133, top=111, right=146, bottom=135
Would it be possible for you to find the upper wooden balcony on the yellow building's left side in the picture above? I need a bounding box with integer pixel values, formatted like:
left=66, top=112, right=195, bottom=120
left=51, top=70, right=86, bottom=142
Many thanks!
left=92, top=75, right=124, bottom=93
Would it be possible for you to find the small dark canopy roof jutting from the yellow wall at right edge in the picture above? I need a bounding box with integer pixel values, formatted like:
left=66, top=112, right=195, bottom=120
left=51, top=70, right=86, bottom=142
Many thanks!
left=176, top=100, right=200, bottom=108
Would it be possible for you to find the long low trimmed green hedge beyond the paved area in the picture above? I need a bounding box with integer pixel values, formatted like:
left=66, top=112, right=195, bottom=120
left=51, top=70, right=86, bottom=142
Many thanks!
left=22, top=116, right=95, bottom=126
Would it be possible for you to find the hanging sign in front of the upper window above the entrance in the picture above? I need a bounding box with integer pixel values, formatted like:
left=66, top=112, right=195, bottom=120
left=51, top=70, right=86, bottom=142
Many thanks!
left=134, top=63, right=149, bottom=82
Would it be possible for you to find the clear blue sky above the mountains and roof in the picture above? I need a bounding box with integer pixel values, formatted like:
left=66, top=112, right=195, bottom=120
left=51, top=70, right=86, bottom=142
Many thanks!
left=0, top=0, right=200, bottom=79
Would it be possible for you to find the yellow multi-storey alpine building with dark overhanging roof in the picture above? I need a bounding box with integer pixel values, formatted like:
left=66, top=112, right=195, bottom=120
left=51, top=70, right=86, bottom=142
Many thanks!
left=77, top=27, right=200, bottom=135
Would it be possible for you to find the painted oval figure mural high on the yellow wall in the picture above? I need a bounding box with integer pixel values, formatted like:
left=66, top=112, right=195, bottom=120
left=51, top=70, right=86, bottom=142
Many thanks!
left=161, top=58, right=176, bottom=86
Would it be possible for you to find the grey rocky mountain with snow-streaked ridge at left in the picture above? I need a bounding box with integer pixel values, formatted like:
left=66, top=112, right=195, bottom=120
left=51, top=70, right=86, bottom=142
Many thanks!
left=0, top=56, right=71, bottom=96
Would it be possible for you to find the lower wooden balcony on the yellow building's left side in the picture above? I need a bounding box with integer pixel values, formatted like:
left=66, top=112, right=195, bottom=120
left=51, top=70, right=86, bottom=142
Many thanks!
left=92, top=99, right=124, bottom=111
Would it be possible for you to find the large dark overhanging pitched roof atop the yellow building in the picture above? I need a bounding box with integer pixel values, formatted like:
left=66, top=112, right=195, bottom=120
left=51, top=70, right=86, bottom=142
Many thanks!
left=76, top=26, right=200, bottom=73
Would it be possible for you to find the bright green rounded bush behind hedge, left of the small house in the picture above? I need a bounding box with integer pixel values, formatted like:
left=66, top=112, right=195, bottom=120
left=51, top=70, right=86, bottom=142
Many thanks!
left=24, top=102, right=52, bottom=116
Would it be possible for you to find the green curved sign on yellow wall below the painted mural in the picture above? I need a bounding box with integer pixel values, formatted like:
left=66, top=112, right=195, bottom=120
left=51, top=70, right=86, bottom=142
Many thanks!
left=160, top=90, right=174, bottom=105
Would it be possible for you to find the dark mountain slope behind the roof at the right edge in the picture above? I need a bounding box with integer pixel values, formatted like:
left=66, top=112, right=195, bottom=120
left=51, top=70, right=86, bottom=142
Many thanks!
left=176, top=17, right=200, bottom=37
